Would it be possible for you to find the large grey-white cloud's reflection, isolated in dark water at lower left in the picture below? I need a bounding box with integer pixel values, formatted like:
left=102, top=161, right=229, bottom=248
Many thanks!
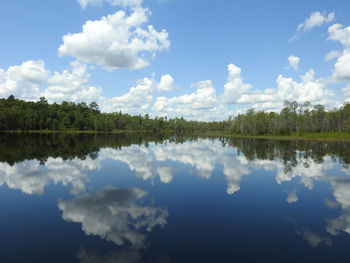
left=58, top=188, right=168, bottom=248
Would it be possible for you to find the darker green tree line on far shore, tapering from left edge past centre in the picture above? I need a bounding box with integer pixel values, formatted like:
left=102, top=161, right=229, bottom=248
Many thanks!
left=0, top=95, right=222, bottom=132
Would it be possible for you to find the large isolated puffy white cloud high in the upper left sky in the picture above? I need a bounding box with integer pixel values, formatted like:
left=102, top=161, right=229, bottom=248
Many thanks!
left=58, top=7, right=170, bottom=70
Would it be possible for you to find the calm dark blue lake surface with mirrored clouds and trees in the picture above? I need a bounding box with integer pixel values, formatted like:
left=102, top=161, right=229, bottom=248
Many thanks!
left=0, top=134, right=350, bottom=263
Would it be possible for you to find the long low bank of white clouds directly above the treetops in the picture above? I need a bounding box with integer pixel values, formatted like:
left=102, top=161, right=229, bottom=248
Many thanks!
left=0, top=60, right=340, bottom=121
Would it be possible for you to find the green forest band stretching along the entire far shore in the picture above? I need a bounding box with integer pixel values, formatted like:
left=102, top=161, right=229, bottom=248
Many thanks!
left=0, top=95, right=350, bottom=136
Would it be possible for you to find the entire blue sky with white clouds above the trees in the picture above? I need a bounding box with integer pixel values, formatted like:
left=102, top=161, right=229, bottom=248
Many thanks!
left=0, top=0, right=350, bottom=120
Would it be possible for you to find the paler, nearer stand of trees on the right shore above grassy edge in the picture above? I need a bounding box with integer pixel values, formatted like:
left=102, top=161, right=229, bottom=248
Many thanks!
left=227, top=101, right=350, bottom=135
